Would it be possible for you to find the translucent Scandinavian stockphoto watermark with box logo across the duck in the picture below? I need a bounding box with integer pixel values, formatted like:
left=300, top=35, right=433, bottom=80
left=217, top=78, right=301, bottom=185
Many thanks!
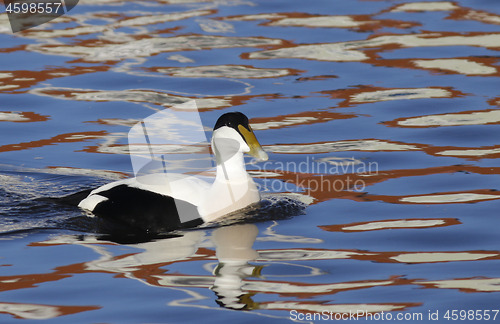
left=128, top=100, right=379, bottom=223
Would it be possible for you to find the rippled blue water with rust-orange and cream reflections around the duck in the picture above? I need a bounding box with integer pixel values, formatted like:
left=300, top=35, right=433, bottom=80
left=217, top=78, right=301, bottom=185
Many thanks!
left=0, top=0, right=500, bottom=323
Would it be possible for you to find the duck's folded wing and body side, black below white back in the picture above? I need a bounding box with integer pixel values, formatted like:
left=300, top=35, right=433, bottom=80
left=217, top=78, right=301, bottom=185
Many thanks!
left=75, top=173, right=210, bottom=233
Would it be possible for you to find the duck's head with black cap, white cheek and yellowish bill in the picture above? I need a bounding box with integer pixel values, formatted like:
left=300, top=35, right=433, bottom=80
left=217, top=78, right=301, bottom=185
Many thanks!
left=212, top=112, right=268, bottom=161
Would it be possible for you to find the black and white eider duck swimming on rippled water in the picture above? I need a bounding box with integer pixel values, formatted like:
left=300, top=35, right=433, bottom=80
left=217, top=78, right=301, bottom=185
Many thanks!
left=55, top=112, right=268, bottom=233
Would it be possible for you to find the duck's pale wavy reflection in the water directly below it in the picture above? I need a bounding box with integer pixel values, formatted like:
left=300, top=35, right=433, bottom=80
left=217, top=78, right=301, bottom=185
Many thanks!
left=86, top=224, right=265, bottom=310
